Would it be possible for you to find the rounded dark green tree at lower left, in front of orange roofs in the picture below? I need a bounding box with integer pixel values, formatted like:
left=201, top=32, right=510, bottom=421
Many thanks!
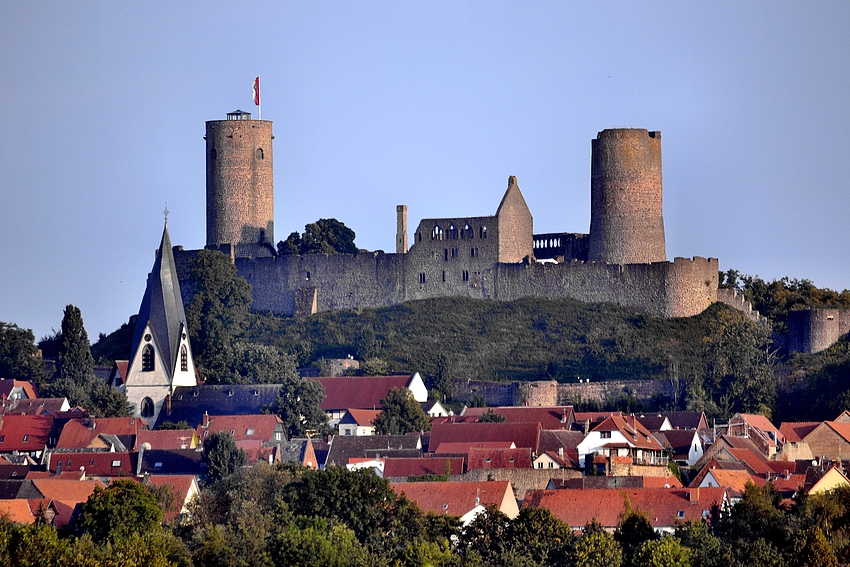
left=77, top=480, right=162, bottom=543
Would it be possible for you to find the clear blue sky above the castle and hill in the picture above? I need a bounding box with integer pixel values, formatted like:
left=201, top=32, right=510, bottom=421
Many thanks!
left=0, top=0, right=850, bottom=340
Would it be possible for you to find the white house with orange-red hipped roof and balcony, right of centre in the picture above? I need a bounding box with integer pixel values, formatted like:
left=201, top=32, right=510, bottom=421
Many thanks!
left=577, top=415, right=667, bottom=474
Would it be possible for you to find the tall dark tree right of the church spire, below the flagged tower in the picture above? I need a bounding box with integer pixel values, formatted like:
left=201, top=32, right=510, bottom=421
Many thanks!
left=186, top=250, right=253, bottom=366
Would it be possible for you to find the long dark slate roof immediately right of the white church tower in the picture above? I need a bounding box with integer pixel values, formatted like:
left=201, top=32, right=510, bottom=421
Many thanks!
left=156, top=384, right=281, bottom=428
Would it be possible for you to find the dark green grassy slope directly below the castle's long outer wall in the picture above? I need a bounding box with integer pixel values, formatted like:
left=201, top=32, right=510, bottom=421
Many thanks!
left=243, top=298, right=729, bottom=381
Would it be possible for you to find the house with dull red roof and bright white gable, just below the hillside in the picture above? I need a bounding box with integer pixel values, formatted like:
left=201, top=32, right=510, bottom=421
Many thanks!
left=308, top=372, right=428, bottom=427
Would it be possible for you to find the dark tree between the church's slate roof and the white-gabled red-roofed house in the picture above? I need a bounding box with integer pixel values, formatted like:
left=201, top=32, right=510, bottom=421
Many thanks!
left=269, top=378, right=328, bottom=439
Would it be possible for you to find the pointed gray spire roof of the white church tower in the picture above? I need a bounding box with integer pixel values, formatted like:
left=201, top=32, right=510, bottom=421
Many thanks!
left=130, top=220, right=186, bottom=377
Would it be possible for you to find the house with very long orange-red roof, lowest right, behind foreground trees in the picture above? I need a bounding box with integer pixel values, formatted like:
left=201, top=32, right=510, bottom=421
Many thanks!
left=523, top=488, right=729, bottom=534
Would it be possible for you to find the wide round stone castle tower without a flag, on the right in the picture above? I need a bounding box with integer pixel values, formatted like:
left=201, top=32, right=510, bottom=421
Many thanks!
left=588, top=128, right=667, bottom=264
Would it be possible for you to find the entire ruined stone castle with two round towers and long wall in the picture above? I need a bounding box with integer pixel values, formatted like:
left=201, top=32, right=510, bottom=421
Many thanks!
left=174, top=111, right=718, bottom=317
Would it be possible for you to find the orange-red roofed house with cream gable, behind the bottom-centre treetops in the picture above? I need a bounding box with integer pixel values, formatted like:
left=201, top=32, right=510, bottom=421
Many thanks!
left=390, top=480, right=519, bottom=526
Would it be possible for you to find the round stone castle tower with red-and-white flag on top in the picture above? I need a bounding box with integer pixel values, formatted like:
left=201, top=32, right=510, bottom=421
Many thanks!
left=204, top=110, right=274, bottom=247
